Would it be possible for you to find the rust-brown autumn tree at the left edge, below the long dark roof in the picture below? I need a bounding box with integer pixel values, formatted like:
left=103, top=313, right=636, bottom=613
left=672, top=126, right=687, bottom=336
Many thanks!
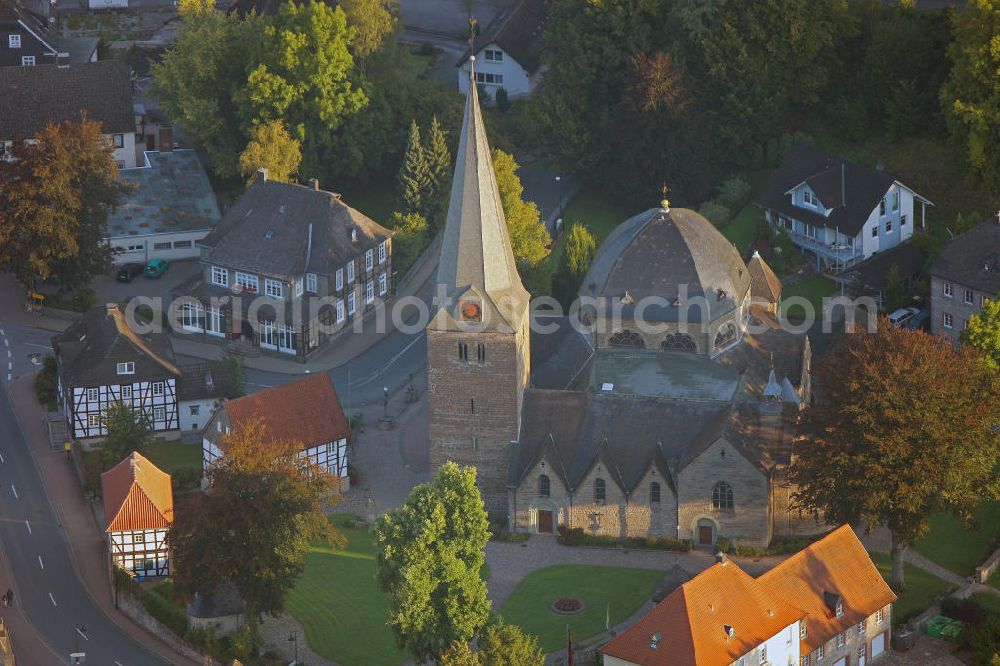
left=0, top=114, right=127, bottom=288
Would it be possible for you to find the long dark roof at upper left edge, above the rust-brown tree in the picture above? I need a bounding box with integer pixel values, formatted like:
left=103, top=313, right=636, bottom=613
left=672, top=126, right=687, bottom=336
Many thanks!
left=0, top=60, right=135, bottom=140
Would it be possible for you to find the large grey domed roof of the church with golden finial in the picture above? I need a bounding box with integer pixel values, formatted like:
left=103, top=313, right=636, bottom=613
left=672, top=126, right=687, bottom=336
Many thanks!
left=580, top=208, right=750, bottom=322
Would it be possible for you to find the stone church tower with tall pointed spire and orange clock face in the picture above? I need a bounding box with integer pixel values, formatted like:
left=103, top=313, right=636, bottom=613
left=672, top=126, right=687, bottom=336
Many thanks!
left=427, top=59, right=530, bottom=519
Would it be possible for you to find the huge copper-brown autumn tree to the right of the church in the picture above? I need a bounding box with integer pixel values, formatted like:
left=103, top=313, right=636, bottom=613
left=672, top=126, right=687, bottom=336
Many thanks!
left=791, top=318, right=1000, bottom=591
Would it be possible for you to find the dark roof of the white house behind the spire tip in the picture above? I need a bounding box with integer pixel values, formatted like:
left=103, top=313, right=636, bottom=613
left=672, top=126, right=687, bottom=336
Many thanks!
left=457, top=0, right=551, bottom=74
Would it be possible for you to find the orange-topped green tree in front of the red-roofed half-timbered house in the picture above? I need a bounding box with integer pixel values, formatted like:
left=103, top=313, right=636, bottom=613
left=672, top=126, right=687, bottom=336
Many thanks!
left=168, top=422, right=343, bottom=620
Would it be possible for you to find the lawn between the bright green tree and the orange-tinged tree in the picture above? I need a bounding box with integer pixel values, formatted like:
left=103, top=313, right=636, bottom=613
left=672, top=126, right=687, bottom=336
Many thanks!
left=285, top=514, right=409, bottom=664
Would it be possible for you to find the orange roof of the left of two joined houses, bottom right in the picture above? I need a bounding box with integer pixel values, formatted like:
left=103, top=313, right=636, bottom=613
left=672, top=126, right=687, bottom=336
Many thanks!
left=600, top=562, right=805, bottom=666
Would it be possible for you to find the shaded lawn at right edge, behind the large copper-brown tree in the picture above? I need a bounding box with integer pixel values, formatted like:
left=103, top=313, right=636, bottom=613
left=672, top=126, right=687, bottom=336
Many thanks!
left=915, top=502, right=1000, bottom=576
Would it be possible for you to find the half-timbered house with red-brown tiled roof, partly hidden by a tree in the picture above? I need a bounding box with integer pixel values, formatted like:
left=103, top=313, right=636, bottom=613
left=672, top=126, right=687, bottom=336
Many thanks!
left=202, top=373, right=350, bottom=490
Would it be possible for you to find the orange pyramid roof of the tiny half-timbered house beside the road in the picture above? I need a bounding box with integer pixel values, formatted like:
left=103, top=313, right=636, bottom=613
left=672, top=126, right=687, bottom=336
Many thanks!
left=101, top=451, right=174, bottom=532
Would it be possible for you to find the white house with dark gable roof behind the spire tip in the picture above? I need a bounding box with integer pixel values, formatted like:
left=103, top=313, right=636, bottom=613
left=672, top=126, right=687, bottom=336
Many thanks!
left=457, top=0, right=551, bottom=99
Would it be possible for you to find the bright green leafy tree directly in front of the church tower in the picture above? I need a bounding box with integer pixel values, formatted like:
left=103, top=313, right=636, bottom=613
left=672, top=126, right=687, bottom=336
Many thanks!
left=375, top=462, right=490, bottom=662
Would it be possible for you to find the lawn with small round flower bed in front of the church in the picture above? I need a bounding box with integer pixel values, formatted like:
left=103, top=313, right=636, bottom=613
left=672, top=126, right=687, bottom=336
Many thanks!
left=500, top=566, right=663, bottom=652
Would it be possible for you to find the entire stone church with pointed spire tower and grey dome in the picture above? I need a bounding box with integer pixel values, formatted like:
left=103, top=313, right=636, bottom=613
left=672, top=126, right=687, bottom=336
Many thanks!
left=427, top=62, right=824, bottom=546
